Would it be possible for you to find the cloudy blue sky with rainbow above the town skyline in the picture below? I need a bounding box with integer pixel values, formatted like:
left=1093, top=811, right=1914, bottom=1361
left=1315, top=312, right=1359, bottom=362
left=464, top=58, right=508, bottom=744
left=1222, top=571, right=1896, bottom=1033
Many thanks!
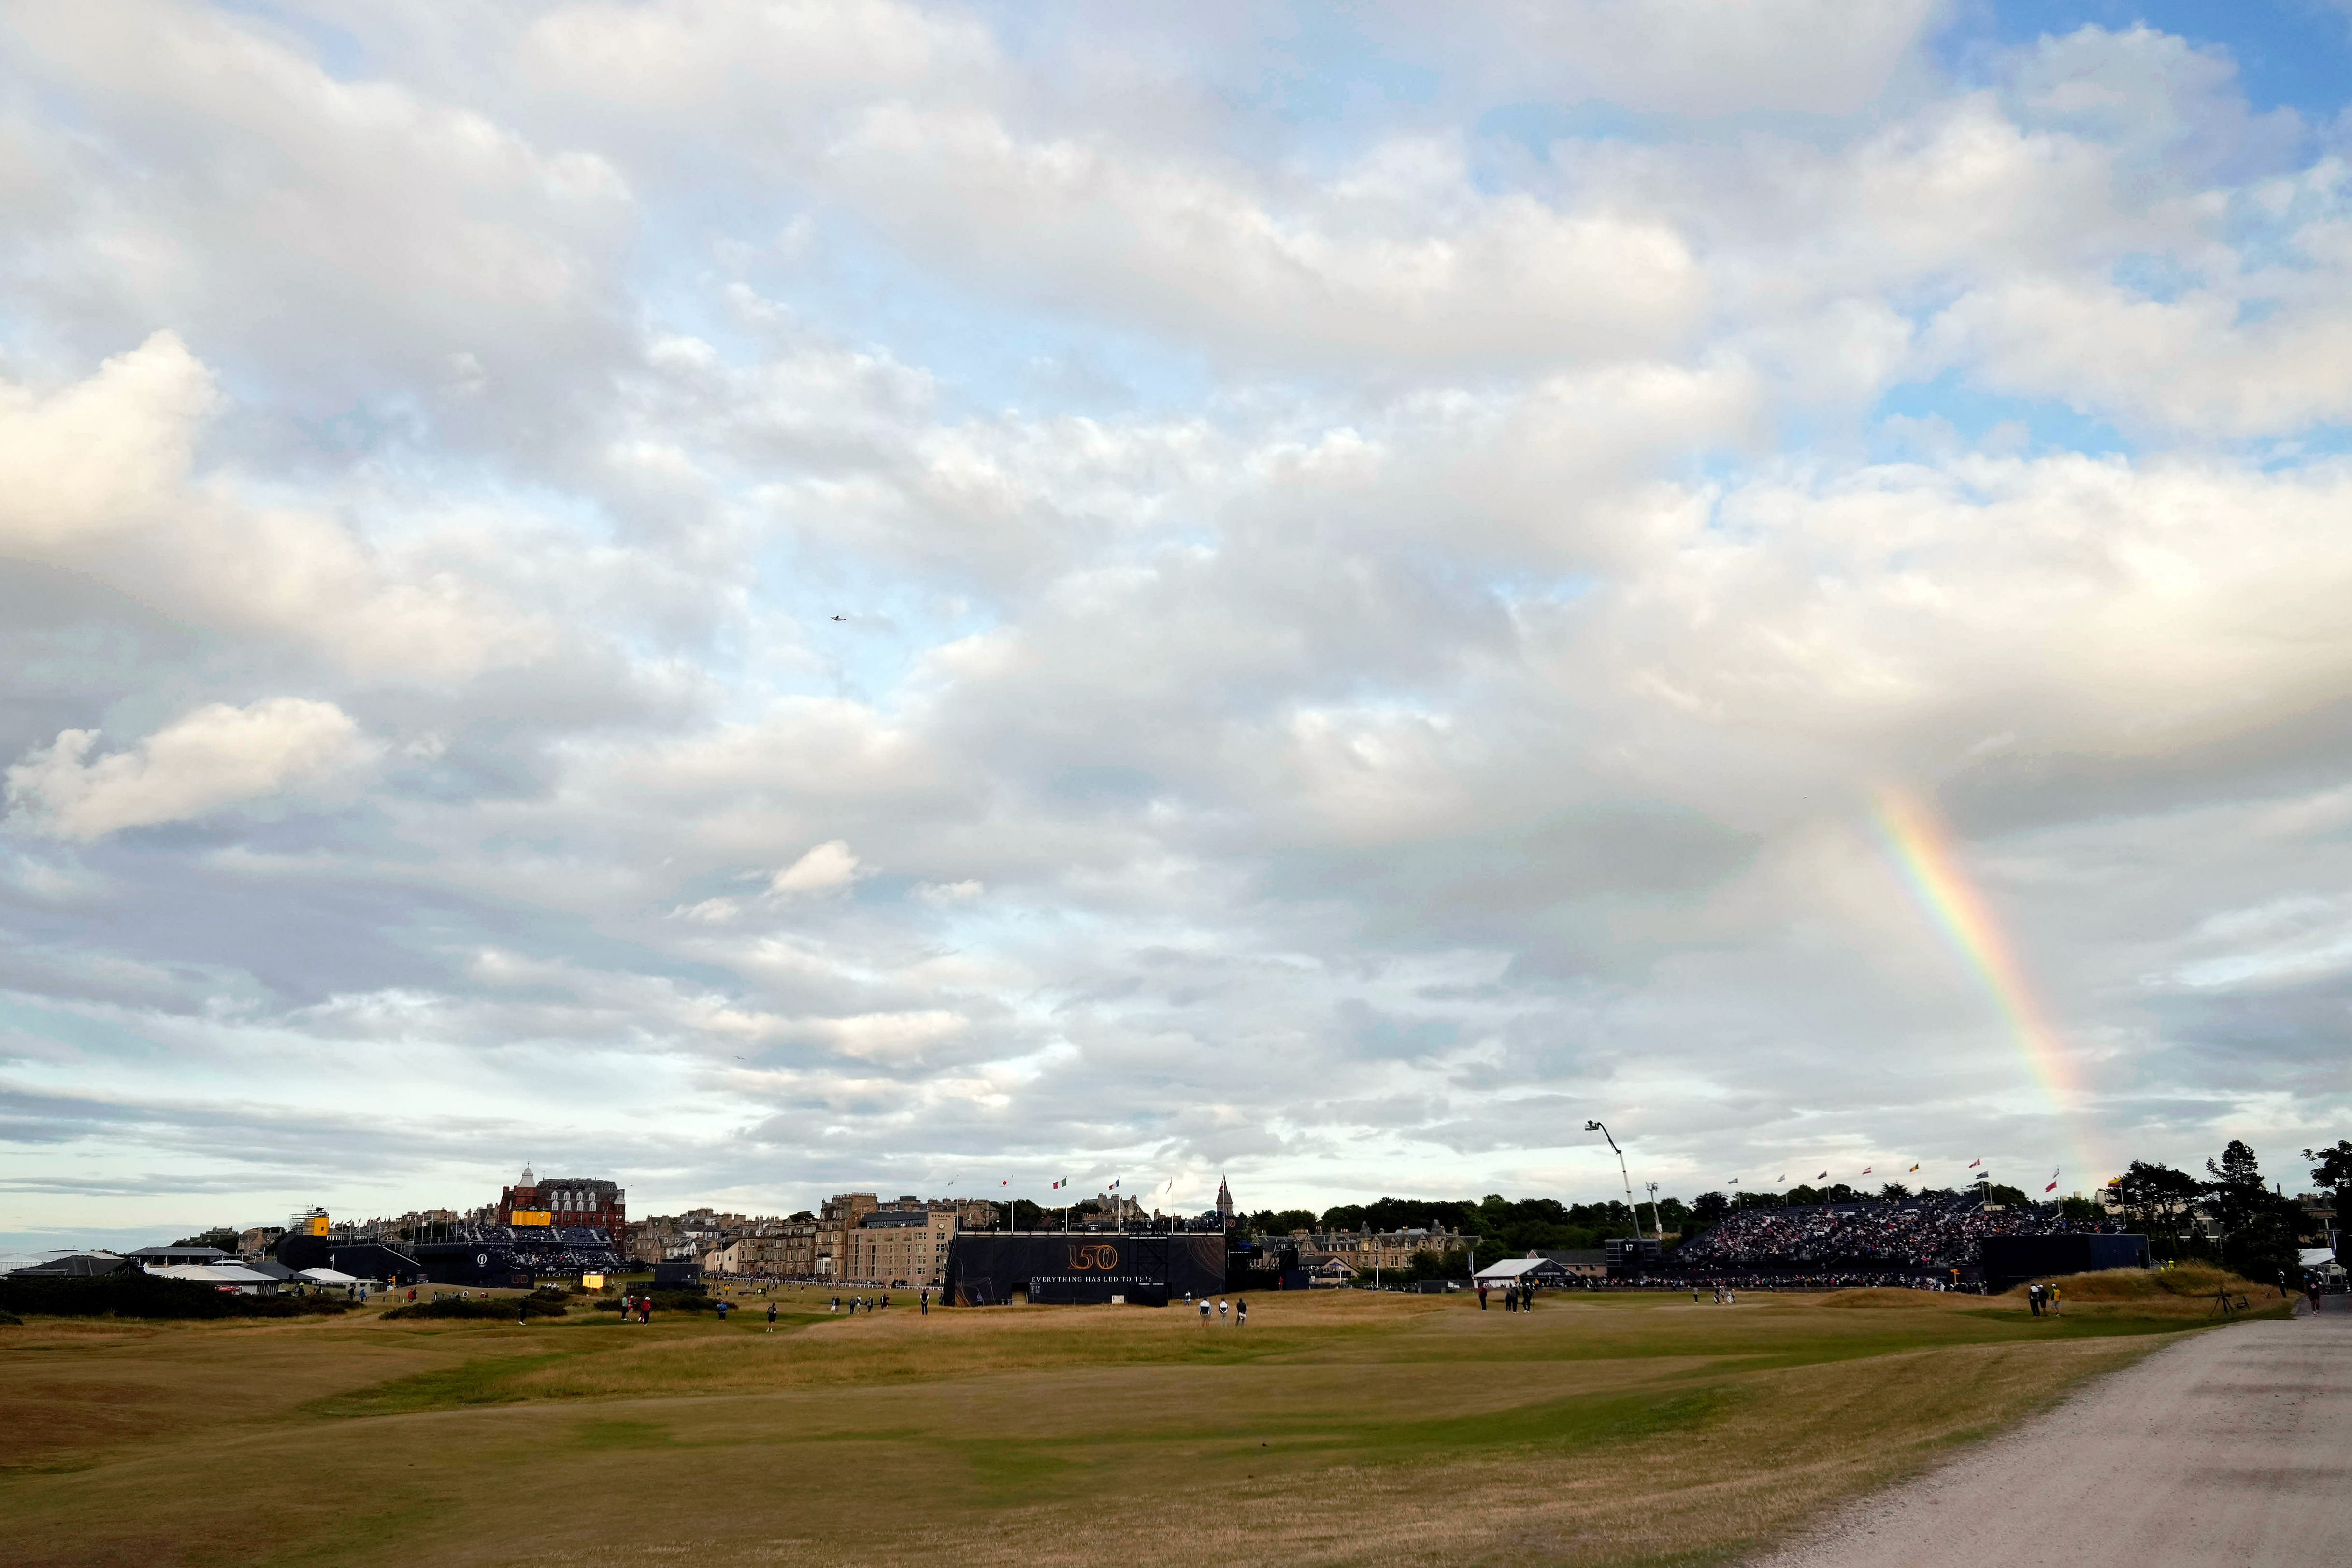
left=0, top=0, right=2352, bottom=1243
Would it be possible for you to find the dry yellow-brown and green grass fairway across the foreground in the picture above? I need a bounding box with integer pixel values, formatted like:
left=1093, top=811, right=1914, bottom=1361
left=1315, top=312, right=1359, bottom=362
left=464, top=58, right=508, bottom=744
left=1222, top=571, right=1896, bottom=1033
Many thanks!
left=0, top=1291, right=2277, bottom=1568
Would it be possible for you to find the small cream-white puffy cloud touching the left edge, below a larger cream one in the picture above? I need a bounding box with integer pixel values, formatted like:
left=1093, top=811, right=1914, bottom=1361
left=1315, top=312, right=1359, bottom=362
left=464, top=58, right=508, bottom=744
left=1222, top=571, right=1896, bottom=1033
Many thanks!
left=7, top=696, right=383, bottom=839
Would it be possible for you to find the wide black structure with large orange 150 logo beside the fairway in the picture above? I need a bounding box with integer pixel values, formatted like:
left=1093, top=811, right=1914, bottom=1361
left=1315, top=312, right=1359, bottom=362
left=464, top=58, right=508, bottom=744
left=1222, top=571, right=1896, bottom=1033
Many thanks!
left=938, top=1229, right=1225, bottom=1307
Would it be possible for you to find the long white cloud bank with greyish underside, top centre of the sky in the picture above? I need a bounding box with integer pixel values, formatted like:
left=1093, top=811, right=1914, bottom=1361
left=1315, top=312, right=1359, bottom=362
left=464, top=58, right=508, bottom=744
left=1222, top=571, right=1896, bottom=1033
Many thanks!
left=830, top=103, right=1705, bottom=362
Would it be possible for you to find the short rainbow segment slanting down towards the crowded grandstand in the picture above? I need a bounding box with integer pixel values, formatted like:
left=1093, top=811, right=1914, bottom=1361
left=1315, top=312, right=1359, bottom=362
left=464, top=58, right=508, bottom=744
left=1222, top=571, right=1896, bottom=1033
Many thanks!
left=1872, top=790, right=2100, bottom=1197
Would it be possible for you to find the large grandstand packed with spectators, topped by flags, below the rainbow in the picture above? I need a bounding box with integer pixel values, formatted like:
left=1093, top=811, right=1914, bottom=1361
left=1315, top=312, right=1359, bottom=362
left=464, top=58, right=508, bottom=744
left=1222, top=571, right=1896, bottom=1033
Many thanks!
left=1663, top=1194, right=2117, bottom=1283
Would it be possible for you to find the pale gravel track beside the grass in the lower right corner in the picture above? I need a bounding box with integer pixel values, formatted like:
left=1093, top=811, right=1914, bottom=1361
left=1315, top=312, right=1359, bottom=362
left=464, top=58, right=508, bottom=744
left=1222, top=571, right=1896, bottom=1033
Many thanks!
left=1755, top=1297, right=2352, bottom=1568
